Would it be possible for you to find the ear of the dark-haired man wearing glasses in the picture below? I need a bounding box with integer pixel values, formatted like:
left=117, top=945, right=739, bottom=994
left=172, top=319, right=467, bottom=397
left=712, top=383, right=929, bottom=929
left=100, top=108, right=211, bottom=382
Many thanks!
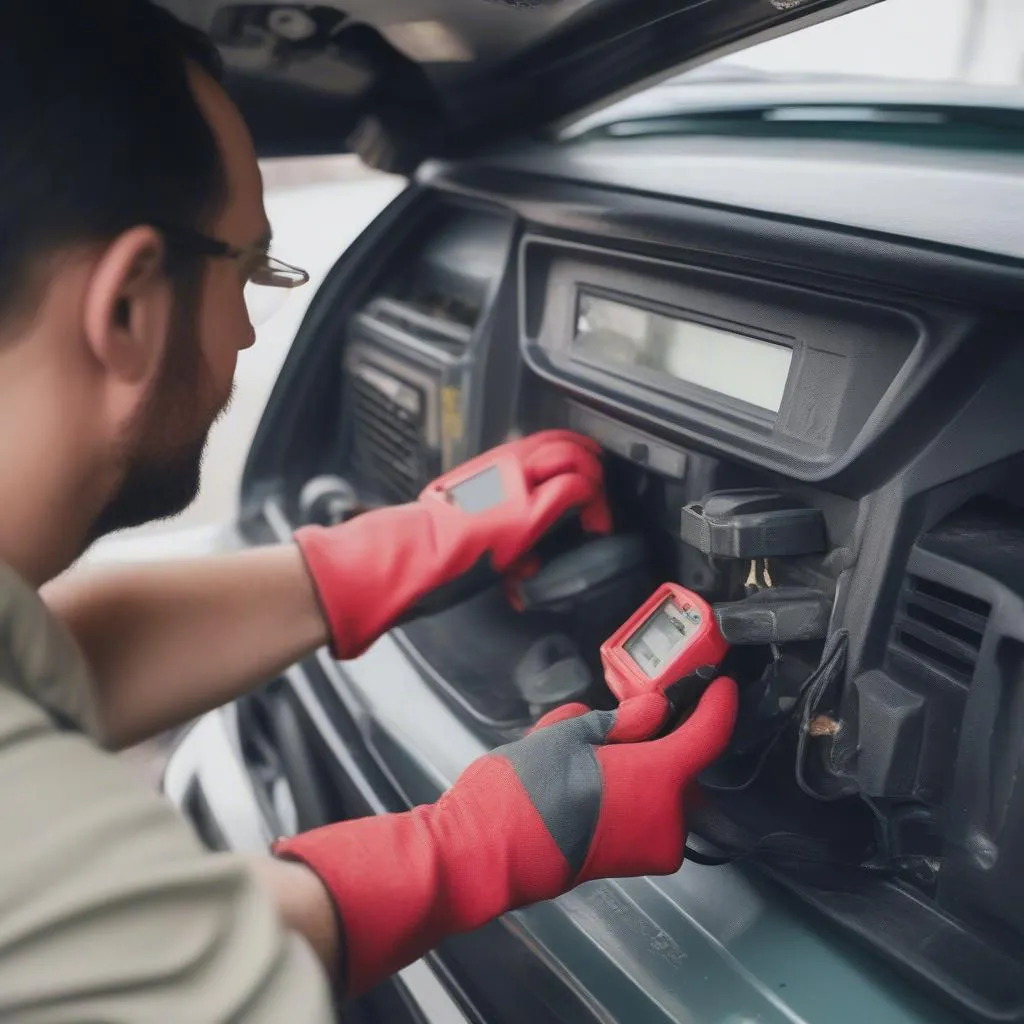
left=83, top=227, right=174, bottom=400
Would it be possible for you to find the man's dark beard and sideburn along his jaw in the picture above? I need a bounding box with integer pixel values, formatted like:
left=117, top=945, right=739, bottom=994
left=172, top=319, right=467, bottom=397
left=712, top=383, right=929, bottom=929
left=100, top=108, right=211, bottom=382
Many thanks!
left=87, top=278, right=232, bottom=546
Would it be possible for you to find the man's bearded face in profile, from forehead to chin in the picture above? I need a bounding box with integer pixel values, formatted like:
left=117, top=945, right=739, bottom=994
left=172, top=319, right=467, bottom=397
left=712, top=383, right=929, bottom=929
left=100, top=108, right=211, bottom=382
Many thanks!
left=89, top=62, right=268, bottom=542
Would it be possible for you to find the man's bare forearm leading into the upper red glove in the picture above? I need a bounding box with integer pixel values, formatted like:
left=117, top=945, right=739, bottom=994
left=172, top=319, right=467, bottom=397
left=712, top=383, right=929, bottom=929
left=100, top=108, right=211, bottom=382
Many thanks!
left=42, top=545, right=328, bottom=748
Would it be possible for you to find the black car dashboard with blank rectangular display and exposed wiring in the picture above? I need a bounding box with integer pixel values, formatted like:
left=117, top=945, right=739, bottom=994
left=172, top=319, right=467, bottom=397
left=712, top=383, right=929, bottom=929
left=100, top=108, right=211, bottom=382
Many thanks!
left=249, top=138, right=1024, bottom=1021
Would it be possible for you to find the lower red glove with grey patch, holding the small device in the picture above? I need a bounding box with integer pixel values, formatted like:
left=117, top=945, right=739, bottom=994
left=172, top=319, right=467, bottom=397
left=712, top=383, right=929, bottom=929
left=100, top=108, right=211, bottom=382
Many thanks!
left=274, top=677, right=737, bottom=995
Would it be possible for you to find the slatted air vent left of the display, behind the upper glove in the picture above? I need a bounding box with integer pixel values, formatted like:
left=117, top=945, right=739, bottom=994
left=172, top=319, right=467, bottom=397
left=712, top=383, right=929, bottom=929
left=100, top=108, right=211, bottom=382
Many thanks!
left=349, top=362, right=425, bottom=502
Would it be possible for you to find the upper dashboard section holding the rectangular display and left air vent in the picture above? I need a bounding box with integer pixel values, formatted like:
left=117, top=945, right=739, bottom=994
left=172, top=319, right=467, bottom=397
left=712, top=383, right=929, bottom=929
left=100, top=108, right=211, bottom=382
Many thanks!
left=346, top=194, right=995, bottom=498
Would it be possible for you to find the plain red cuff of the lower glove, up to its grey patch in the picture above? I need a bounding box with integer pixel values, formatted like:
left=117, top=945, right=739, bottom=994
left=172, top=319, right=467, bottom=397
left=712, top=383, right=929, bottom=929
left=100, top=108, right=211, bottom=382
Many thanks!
left=273, top=755, right=569, bottom=996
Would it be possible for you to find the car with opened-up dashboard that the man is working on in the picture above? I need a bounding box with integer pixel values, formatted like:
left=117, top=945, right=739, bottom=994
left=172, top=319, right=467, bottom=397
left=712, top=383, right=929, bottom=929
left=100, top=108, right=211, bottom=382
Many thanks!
left=96, top=0, right=1024, bottom=1024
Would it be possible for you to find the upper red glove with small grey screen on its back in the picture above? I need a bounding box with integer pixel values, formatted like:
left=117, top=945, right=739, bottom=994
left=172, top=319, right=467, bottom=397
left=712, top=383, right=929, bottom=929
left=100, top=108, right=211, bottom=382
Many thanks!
left=295, top=430, right=611, bottom=658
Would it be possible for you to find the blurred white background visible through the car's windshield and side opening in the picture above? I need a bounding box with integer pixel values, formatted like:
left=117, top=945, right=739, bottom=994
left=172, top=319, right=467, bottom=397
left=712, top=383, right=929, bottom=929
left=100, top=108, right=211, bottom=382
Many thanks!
left=114, top=0, right=1024, bottom=538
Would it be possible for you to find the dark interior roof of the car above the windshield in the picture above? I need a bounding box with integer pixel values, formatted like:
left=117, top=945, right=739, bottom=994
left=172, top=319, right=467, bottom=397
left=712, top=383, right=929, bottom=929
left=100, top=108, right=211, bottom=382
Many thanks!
left=155, top=0, right=878, bottom=173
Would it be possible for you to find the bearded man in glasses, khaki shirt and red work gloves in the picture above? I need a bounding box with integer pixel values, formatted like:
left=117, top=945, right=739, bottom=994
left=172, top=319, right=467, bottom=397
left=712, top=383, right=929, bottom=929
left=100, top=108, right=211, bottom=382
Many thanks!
left=0, top=0, right=736, bottom=1024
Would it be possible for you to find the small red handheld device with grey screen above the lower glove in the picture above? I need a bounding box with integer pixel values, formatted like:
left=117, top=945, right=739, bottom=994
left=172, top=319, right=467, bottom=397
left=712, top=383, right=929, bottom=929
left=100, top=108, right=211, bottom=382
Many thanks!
left=601, top=583, right=729, bottom=700
